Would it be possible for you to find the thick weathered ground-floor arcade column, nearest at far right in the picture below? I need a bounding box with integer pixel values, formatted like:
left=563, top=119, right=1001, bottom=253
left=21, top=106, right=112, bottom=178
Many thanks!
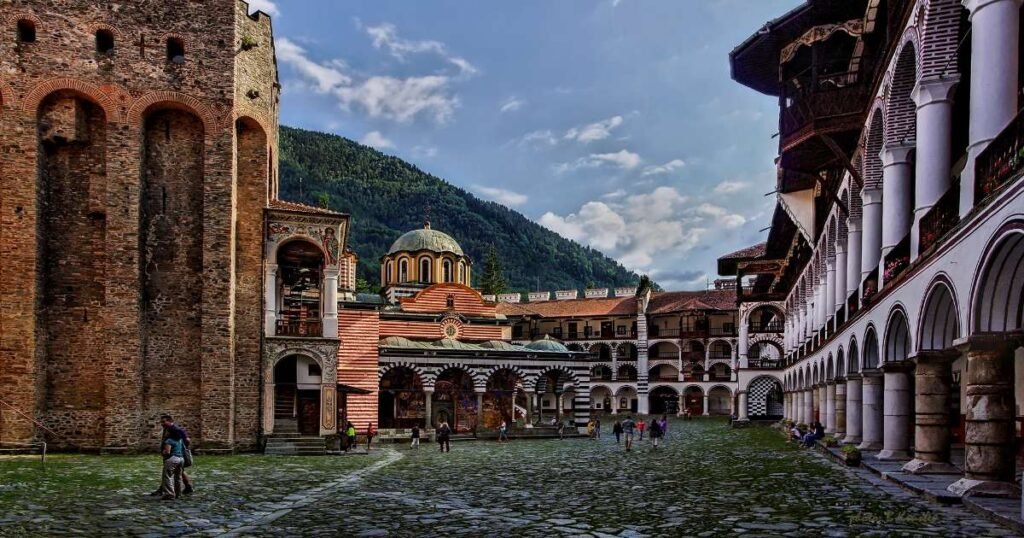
left=948, top=336, right=1020, bottom=495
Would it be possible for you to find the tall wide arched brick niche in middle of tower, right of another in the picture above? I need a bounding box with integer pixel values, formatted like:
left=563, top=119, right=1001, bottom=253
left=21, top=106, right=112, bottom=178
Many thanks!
left=139, top=101, right=205, bottom=424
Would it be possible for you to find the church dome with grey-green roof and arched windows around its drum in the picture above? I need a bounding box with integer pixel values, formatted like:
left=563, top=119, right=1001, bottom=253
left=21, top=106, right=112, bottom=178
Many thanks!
left=381, top=222, right=473, bottom=288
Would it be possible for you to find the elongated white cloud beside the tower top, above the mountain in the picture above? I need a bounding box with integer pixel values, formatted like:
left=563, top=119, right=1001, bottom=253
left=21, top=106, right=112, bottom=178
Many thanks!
left=276, top=38, right=460, bottom=123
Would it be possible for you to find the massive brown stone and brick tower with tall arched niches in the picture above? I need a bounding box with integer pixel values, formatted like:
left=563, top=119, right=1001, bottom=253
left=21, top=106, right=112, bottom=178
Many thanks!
left=0, top=0, right=280, bottom=449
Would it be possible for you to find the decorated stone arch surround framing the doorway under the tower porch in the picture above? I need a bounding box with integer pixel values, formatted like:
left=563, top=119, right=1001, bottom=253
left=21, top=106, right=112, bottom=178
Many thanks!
left=261, top=337, right=338, bottom=436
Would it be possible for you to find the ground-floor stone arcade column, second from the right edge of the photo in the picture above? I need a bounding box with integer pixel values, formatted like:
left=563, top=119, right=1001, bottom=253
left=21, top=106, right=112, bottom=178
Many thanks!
left=903, top=351, right=959, bottom=474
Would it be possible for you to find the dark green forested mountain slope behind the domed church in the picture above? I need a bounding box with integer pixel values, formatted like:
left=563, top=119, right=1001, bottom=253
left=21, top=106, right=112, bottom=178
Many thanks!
left=281, top=126, right=639, bottom=291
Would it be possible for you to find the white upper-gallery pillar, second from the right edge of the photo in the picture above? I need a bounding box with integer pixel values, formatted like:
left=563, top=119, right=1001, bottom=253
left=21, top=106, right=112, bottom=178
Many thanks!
left=910, top=75, right=959, bottom=261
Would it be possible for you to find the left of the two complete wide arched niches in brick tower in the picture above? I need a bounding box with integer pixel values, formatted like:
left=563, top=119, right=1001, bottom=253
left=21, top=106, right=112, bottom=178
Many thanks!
left=35, top=89, right=108, bottom=446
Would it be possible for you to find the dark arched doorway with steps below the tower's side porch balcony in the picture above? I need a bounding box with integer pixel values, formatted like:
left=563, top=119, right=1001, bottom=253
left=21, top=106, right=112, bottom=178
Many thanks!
left=273, top=355, right=321, bottom=436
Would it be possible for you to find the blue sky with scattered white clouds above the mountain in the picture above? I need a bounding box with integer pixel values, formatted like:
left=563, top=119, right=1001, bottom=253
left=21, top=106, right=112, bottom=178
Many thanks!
left=252, top=0, right=800, bottom=289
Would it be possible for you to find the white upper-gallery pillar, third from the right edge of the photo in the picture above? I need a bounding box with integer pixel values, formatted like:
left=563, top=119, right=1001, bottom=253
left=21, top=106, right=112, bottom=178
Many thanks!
left=879, top=143, right=914, bottom=289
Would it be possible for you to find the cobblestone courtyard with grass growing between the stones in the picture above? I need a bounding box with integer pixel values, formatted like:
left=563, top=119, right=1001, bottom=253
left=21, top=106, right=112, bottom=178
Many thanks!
left=0, top=420, right=1011, bottom=536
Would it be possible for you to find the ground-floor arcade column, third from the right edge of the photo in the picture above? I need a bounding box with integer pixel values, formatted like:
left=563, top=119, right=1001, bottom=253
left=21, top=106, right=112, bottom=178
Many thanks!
left=878, top=363, right=913, bottom=459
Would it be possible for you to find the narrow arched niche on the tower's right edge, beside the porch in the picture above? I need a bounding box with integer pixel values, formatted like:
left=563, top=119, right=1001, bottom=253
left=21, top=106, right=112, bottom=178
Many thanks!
left=234, top=118, right=270, bottom=446
